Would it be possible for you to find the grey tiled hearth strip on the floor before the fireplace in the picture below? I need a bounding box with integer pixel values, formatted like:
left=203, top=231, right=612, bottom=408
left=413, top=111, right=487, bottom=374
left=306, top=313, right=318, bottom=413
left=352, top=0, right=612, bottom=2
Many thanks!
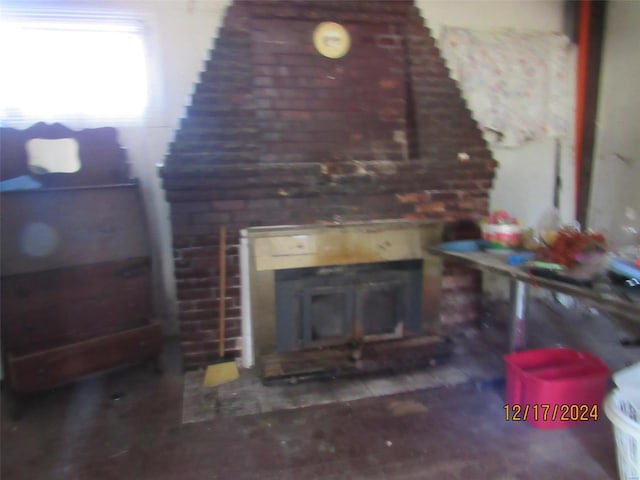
left=182, top=345, right=504, bottom=423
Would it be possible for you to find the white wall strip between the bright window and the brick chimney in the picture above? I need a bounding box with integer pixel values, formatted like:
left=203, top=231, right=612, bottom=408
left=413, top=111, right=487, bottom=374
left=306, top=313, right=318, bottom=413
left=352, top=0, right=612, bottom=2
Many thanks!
left=109, top=0, right=230, bottom=334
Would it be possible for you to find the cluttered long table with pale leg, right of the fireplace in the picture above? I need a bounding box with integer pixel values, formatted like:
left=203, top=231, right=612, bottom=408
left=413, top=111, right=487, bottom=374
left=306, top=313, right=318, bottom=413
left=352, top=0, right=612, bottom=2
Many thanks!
left=430, top=248, right=640, bottom=351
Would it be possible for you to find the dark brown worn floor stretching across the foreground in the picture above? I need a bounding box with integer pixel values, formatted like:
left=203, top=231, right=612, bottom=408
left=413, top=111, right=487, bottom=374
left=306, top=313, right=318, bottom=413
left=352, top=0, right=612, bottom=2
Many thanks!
left=0, top=296, right=640, bottom=480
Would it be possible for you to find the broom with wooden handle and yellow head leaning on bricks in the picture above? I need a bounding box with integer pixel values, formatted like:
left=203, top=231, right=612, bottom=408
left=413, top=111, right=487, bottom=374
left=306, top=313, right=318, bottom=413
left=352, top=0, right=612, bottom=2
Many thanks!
left=203, top=226, right=238, bottom=387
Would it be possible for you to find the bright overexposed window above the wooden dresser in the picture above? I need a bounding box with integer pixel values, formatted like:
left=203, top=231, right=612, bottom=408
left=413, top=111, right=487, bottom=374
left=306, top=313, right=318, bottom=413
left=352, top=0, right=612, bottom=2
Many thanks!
left=0, top=12, right=148, bottom=122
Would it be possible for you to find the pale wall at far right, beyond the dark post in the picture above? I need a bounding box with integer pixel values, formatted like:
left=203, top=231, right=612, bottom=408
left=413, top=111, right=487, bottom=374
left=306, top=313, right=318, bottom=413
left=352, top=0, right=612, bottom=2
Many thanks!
left=589, top=0, right=640, bottom=246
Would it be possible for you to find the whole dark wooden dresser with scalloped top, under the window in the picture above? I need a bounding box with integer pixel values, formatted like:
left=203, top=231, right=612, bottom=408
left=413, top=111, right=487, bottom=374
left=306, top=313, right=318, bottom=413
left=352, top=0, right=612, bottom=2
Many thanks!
left=0, top=124, right=162, bottom=393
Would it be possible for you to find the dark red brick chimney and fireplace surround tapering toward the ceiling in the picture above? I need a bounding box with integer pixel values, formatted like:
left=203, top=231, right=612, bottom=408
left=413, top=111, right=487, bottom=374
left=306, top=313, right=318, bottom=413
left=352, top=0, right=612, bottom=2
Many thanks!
left=160, top=0, right=495, bottom=368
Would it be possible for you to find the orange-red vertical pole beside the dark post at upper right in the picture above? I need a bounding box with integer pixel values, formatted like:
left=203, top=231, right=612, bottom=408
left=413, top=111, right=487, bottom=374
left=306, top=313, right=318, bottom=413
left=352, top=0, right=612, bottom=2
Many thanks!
left=575, top=0, right=592, bottom=218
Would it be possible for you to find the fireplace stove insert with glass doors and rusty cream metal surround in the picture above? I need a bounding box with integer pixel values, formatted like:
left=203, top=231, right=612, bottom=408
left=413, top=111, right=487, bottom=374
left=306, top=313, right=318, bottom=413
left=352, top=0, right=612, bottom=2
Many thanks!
left=241, top=220, right=448, bottom=378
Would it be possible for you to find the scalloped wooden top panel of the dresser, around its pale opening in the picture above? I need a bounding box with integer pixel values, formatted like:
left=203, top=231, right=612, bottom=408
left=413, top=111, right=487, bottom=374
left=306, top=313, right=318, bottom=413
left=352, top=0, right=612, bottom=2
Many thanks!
left=0, top=123, right=131, bottom=187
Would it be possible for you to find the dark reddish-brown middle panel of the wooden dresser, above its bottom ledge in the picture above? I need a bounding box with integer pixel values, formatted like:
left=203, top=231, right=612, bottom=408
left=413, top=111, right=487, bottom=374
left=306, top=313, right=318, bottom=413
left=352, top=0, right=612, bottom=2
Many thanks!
left=1, top=257, right=151, bottom=355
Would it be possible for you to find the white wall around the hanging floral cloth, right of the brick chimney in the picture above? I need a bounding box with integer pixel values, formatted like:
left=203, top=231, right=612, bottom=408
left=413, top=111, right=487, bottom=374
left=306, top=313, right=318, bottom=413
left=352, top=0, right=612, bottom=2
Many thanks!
left=416, top=0, right=575, bottom=227
